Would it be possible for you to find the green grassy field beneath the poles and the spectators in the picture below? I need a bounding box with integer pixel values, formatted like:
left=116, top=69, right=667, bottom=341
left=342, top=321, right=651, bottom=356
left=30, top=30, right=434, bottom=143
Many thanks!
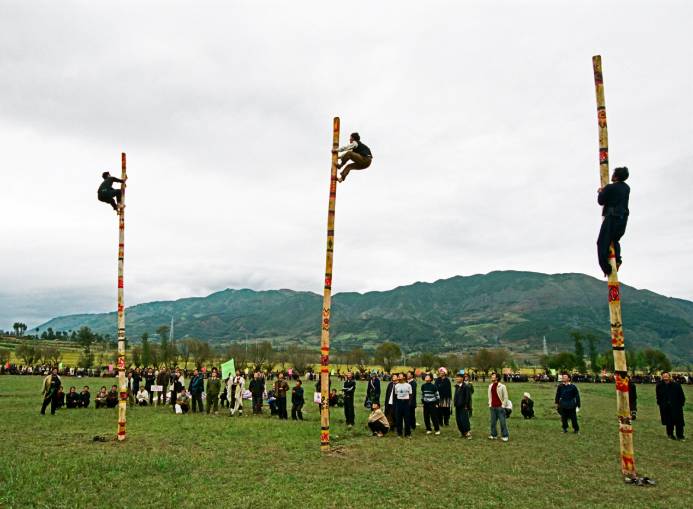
left=0, top=376, right=693, bottom=508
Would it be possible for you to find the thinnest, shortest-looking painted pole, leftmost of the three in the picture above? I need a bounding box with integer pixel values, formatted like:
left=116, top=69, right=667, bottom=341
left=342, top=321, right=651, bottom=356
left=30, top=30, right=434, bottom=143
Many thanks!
left=118, top=153, right=128, bottom=440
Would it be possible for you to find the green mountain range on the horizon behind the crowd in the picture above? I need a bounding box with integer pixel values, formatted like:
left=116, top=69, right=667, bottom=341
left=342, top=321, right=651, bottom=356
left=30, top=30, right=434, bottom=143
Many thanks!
left=32, top=271, right=693, bottom=362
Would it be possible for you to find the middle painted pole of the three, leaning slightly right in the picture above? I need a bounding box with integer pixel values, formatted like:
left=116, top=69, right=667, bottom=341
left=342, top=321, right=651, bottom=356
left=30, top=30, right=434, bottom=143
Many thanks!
left=320, top=117, right=339, bottom=452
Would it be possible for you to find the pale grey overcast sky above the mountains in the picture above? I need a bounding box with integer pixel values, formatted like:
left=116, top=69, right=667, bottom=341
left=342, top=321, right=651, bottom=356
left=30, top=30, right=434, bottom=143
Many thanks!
left=0, top=0, right=693, bottom=329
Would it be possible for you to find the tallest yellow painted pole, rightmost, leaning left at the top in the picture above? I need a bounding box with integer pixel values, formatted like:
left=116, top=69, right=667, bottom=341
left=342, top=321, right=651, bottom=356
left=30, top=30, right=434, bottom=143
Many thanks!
left=592, top=55, right=636, bottom=479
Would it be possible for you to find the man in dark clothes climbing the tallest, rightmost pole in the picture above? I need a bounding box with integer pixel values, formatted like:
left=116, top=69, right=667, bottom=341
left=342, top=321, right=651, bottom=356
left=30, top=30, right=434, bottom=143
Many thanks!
left=597, top=166, right=630, bottom=276
